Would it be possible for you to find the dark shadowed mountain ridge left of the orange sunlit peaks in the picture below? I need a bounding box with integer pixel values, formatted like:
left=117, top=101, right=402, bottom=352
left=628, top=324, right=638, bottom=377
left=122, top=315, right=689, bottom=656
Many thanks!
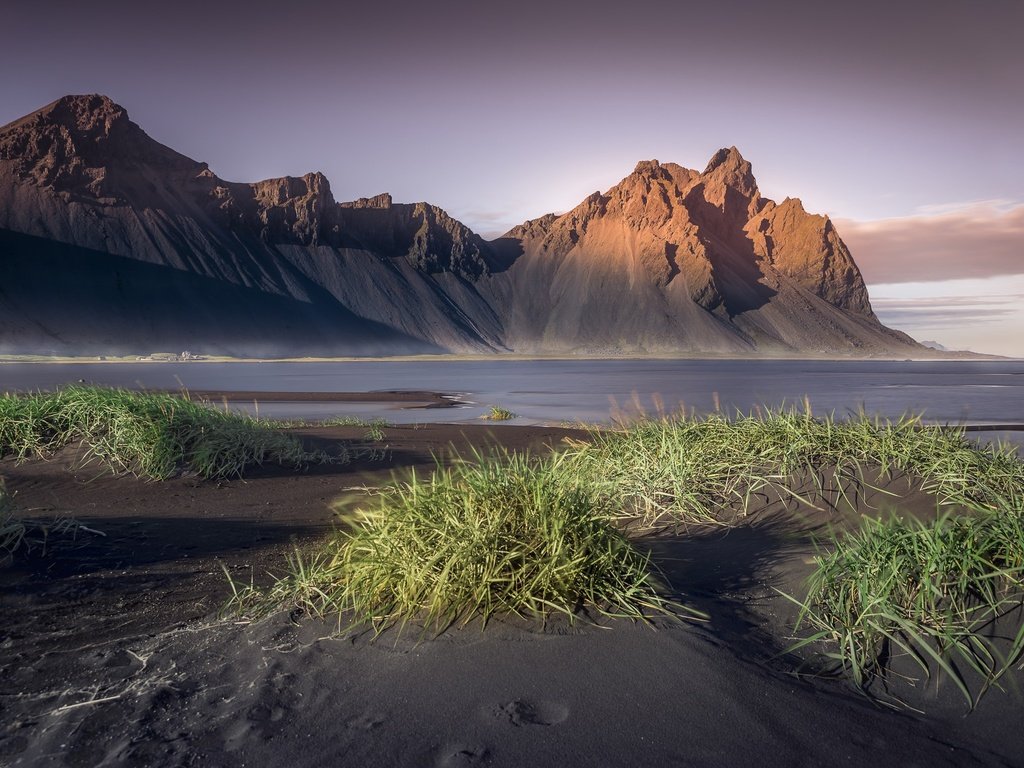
left=0, top=96, right=501, bottom=354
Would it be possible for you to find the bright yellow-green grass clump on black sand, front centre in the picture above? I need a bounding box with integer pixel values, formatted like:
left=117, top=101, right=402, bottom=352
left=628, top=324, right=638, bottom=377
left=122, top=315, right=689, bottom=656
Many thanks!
left=239, top=454, right=665, bottom=629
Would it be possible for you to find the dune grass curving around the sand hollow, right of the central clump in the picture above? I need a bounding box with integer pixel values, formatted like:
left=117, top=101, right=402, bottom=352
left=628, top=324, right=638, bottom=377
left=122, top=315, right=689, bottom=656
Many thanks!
left=566, top=407, right=1024, bottom=703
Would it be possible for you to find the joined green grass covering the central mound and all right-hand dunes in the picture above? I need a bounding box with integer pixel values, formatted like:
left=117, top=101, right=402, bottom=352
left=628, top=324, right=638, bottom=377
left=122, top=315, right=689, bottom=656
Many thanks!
left=222, top=407, right=1024, bottom=701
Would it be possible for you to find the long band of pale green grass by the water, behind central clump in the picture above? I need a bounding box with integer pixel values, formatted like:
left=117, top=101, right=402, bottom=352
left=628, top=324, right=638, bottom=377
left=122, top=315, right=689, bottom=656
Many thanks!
left=568, top=408, right=1024, bottom=523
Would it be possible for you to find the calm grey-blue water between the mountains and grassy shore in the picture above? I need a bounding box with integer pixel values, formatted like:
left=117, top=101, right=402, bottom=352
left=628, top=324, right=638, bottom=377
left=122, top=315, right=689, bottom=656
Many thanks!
left=0, top=359, right=1024, bottom=424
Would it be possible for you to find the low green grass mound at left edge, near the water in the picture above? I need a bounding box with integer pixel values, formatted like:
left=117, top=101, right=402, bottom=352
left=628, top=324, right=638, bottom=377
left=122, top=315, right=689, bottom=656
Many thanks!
left=0, top=386, right=319, bottom=479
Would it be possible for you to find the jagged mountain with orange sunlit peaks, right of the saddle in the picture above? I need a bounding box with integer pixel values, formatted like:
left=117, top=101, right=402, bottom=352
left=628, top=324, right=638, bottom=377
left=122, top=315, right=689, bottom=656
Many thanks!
left=490, top=147, right=913, bottom=353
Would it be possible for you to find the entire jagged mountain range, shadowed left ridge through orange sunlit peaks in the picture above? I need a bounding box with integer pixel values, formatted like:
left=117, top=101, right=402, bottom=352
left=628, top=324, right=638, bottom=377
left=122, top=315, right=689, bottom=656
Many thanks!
left=0, top=95, right=921, bottom=356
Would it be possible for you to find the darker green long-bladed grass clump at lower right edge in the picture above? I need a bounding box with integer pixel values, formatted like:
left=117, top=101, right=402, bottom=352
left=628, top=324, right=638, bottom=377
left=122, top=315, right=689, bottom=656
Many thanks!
left=797, top=497, right=1024, bottom=703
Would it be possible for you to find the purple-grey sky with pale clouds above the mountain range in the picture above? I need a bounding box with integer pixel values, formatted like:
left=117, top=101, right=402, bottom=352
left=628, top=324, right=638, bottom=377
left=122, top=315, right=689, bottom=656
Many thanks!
left=0, top=0, right=1024, bottom=357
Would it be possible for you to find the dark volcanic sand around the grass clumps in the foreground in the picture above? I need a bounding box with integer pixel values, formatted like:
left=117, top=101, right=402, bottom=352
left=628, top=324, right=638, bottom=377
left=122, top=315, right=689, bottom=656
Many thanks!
left=0, top=425, right=1024, bottom=768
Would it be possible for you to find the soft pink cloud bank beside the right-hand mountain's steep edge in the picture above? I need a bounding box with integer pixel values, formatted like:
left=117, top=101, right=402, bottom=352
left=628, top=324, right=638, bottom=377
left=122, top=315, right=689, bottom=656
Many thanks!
left=836, top=201, right=1024, bottom=284
